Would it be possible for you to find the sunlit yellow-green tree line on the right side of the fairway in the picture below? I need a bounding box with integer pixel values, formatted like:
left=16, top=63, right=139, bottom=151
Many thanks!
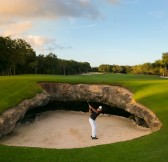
left=97, top=52, right=168, bottom=76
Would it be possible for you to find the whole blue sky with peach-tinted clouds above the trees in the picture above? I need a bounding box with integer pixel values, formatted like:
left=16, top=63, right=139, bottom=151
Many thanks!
left=0, top=0, right=168, bottom=67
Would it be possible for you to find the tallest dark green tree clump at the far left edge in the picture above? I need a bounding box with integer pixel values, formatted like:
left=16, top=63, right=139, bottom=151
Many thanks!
left=0, top=37, right=35, bottom=75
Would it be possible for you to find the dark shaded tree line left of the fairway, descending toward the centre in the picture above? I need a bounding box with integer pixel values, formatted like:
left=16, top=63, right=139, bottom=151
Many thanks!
left=0, top=36, right=91, bottom=75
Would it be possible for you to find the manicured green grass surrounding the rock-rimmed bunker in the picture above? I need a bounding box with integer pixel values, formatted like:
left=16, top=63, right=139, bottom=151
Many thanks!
left=0, top=74, right=168, bottom=162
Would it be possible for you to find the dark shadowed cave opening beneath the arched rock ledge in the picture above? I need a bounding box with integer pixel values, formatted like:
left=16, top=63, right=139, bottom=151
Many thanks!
left=19, top=101, right=148, bottom=128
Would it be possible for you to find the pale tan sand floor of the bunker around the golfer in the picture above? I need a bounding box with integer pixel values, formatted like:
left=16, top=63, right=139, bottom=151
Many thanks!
left=0, top=111, right=151, bottom=148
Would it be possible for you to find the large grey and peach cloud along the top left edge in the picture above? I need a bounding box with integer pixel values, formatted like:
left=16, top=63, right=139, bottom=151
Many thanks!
left=0, top=0, right=101, bottom=22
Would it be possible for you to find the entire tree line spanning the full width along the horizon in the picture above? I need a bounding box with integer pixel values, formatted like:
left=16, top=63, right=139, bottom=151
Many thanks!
left=0, top=36, right=168, bottom=76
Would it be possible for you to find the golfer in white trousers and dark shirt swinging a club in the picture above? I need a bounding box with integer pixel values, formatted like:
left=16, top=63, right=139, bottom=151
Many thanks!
left=89, top=105, right=102, bottom=139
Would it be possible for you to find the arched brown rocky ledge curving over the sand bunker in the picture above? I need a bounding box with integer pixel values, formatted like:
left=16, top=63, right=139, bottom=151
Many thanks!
left=0, top=82, right=162, bottom=136
